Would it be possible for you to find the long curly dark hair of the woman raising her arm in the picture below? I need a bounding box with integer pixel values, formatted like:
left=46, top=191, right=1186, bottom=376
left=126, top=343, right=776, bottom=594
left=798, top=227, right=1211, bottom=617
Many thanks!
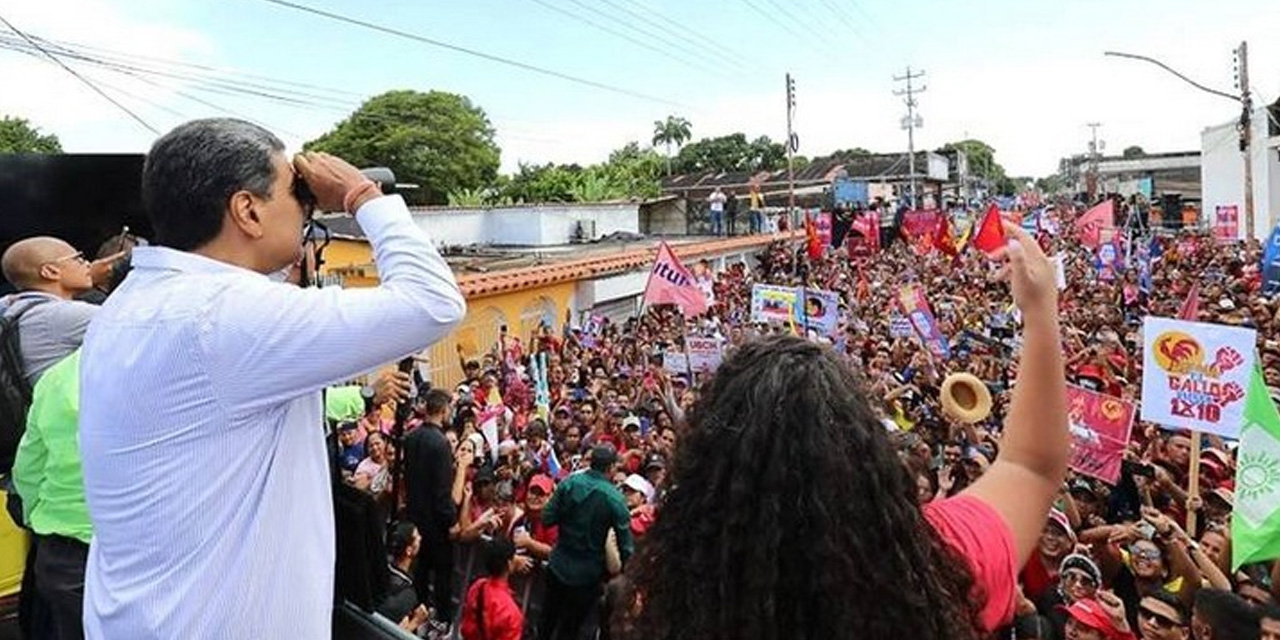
left=614, top=337, right=986, bottom=640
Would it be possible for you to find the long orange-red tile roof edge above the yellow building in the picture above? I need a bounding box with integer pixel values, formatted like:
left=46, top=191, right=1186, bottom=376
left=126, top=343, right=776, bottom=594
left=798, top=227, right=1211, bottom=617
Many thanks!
left=458, top=232, right=803, bottom=300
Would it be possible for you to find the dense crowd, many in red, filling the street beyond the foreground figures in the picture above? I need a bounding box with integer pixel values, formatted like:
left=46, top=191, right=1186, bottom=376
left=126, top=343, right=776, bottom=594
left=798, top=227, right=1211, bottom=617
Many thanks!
left=327, top=197, right=1280, bottom=640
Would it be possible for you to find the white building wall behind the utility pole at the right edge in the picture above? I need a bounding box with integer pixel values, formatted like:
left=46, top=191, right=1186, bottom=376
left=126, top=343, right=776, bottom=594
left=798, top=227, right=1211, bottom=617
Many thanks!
left=1201, top=110, right=1280, bottom=239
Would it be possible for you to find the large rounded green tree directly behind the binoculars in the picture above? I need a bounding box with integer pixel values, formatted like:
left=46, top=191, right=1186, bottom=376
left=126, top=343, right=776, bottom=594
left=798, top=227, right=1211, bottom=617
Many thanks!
left=305, top=91, right=500, bottom=205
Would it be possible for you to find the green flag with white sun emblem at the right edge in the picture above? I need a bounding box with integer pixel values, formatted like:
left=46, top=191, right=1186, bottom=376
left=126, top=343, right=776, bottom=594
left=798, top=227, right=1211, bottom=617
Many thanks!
left=1231, top=365, right=1280, bottom=571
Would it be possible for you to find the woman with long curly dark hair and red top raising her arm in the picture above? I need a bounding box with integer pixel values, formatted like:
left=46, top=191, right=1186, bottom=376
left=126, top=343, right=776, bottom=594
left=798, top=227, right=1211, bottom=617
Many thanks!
left=616, top=224, right=1070, bottom=640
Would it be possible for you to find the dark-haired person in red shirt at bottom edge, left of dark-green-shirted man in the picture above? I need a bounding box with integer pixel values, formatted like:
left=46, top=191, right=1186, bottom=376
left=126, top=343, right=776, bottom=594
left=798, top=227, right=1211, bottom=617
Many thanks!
left=462, top=538, right=525, bottom=640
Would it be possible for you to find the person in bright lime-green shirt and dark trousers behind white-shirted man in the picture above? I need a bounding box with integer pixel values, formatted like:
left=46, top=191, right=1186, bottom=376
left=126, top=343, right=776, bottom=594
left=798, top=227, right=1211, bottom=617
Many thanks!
left=13, top=349, right=93, bottom=640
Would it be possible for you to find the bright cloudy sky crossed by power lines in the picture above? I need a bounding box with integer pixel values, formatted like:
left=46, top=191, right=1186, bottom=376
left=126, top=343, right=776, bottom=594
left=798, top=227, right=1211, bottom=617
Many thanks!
left=0, top=0, right=1280, bottom=175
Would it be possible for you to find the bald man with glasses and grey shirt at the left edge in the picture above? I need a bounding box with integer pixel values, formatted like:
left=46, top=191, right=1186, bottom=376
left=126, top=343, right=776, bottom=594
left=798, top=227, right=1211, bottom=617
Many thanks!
left=0, top=236, right=97, bottom=387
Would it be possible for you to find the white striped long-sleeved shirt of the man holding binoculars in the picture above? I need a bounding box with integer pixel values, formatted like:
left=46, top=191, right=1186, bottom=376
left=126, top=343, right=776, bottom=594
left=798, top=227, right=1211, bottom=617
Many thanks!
left=79, top=196, right=466, bottom=640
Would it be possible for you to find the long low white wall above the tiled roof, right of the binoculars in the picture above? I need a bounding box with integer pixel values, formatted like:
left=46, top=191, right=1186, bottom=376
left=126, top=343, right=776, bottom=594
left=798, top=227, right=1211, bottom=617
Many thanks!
left=413, top=202, right=640, bottom=247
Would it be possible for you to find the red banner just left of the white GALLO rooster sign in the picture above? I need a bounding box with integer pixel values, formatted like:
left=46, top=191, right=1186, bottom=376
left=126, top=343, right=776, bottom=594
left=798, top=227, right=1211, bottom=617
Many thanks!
left=1066, top=385, right=1135, bottom=485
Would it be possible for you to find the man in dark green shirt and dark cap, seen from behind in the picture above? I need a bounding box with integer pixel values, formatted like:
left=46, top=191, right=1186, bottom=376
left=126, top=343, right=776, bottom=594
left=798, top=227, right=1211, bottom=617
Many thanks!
left=538, top=444, right=634, bottom=640
